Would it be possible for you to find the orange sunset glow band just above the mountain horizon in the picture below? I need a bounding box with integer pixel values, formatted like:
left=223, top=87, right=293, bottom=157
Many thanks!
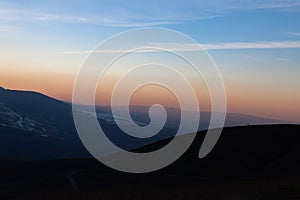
left=0, top=71, right=300, bottom=122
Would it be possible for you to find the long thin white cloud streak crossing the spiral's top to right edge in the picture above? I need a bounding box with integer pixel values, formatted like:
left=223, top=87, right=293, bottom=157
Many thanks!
left=59, top=41, right=300, bottom=55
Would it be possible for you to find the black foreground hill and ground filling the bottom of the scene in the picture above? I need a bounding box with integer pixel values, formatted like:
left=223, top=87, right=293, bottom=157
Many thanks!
left=0, top=125, right=300, bottom=200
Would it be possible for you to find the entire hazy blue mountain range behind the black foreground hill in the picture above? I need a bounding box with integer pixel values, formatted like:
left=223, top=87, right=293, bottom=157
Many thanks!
left=0, top=87, right=292, bottom=160
